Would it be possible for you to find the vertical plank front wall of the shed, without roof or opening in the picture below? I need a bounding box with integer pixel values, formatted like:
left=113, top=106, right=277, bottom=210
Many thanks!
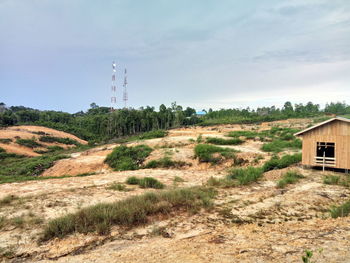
left=301, top=120, right=350, bottom=169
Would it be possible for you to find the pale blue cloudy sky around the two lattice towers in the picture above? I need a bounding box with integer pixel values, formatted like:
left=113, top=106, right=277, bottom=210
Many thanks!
left=0, top=0, right=350, bottom=113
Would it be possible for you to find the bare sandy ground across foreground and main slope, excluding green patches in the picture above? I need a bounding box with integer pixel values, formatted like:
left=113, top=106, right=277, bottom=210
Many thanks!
left=0, top=120, right=350, bottom=262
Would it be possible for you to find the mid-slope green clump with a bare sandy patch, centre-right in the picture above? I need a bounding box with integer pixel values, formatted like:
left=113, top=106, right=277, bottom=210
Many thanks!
left=194, top=144, right=237, bottom=164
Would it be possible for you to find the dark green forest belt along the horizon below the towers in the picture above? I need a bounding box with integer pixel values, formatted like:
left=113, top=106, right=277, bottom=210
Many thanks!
left=0, top=101, right=350, bottom=142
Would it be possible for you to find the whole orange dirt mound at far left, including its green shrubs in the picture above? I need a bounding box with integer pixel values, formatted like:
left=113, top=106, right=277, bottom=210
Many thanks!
left=0, top=126, right=87, bottom=156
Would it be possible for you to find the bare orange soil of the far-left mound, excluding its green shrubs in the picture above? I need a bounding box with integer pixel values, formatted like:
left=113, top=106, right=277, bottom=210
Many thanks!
left=0, top=126, right=87, bottom=156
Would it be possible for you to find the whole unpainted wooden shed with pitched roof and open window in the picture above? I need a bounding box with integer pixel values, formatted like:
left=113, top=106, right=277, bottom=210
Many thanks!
left=295, top=117, right=350, bottom=170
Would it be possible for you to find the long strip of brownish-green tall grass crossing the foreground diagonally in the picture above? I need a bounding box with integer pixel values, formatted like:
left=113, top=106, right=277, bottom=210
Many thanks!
left=40, top=187, right=215, bottom=241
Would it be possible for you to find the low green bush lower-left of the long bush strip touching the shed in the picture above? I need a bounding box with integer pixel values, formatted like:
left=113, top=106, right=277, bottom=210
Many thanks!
left=227, top=167, right=263, bottom=185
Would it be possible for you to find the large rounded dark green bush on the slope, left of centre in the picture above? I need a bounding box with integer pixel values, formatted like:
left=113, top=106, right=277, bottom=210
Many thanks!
left=105, top=145, right=152, bottom=171
